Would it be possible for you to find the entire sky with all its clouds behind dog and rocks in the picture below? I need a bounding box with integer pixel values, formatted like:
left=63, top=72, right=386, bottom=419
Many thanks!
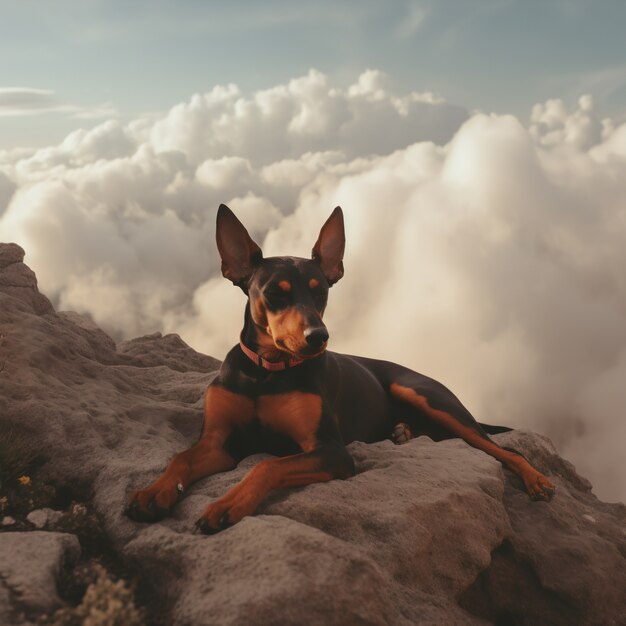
left=0, top=0, right=626, bottom=500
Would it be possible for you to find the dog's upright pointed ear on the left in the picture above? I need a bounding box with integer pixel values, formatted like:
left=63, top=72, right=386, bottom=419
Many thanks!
left=215, top=204, right=263, bottom=291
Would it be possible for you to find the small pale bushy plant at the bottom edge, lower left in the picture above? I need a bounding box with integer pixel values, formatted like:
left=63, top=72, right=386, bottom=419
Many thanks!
left=52, top=564, right=145, bottom=626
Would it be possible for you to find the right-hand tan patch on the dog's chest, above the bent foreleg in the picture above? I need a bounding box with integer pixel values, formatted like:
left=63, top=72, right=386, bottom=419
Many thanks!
left=257, top=391, right=322, bottom=452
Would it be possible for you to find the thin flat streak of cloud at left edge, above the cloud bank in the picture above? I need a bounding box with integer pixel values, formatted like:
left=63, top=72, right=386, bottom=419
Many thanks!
left=0, top=87, right=117, bottom=119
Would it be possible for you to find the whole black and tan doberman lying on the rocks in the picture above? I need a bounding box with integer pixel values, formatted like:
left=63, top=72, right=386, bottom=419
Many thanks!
left=126, top=205, right=554, bottom=533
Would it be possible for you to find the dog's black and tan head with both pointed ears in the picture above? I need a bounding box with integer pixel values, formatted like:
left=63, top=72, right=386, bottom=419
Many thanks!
left=216, top=204, right=345, bottom=358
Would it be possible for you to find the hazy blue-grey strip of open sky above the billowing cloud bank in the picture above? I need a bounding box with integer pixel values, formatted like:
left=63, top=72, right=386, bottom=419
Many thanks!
left=0, top=0, right=626, bottom=147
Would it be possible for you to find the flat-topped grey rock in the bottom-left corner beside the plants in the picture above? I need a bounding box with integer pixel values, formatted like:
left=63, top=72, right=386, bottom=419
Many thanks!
left=0, top=531, right=80, bottom=624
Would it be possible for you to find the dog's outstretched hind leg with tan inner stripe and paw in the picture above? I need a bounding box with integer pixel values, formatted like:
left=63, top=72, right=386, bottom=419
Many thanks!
left=389, top=368, right=555, bottom=500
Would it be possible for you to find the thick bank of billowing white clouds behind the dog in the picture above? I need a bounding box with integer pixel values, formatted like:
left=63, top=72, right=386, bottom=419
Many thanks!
left=0, top=71, right=626, bottom=499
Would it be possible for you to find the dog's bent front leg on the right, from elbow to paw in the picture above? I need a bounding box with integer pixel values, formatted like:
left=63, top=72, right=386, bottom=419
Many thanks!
left=196, top=441, right=355, bottom=534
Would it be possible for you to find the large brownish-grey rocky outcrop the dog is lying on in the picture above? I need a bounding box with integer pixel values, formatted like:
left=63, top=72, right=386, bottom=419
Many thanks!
left=0, top=244, right=626, bottom=625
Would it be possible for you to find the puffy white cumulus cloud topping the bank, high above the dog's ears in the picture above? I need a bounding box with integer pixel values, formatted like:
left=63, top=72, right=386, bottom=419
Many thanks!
left=149, top=70, right=467, bottom=164
